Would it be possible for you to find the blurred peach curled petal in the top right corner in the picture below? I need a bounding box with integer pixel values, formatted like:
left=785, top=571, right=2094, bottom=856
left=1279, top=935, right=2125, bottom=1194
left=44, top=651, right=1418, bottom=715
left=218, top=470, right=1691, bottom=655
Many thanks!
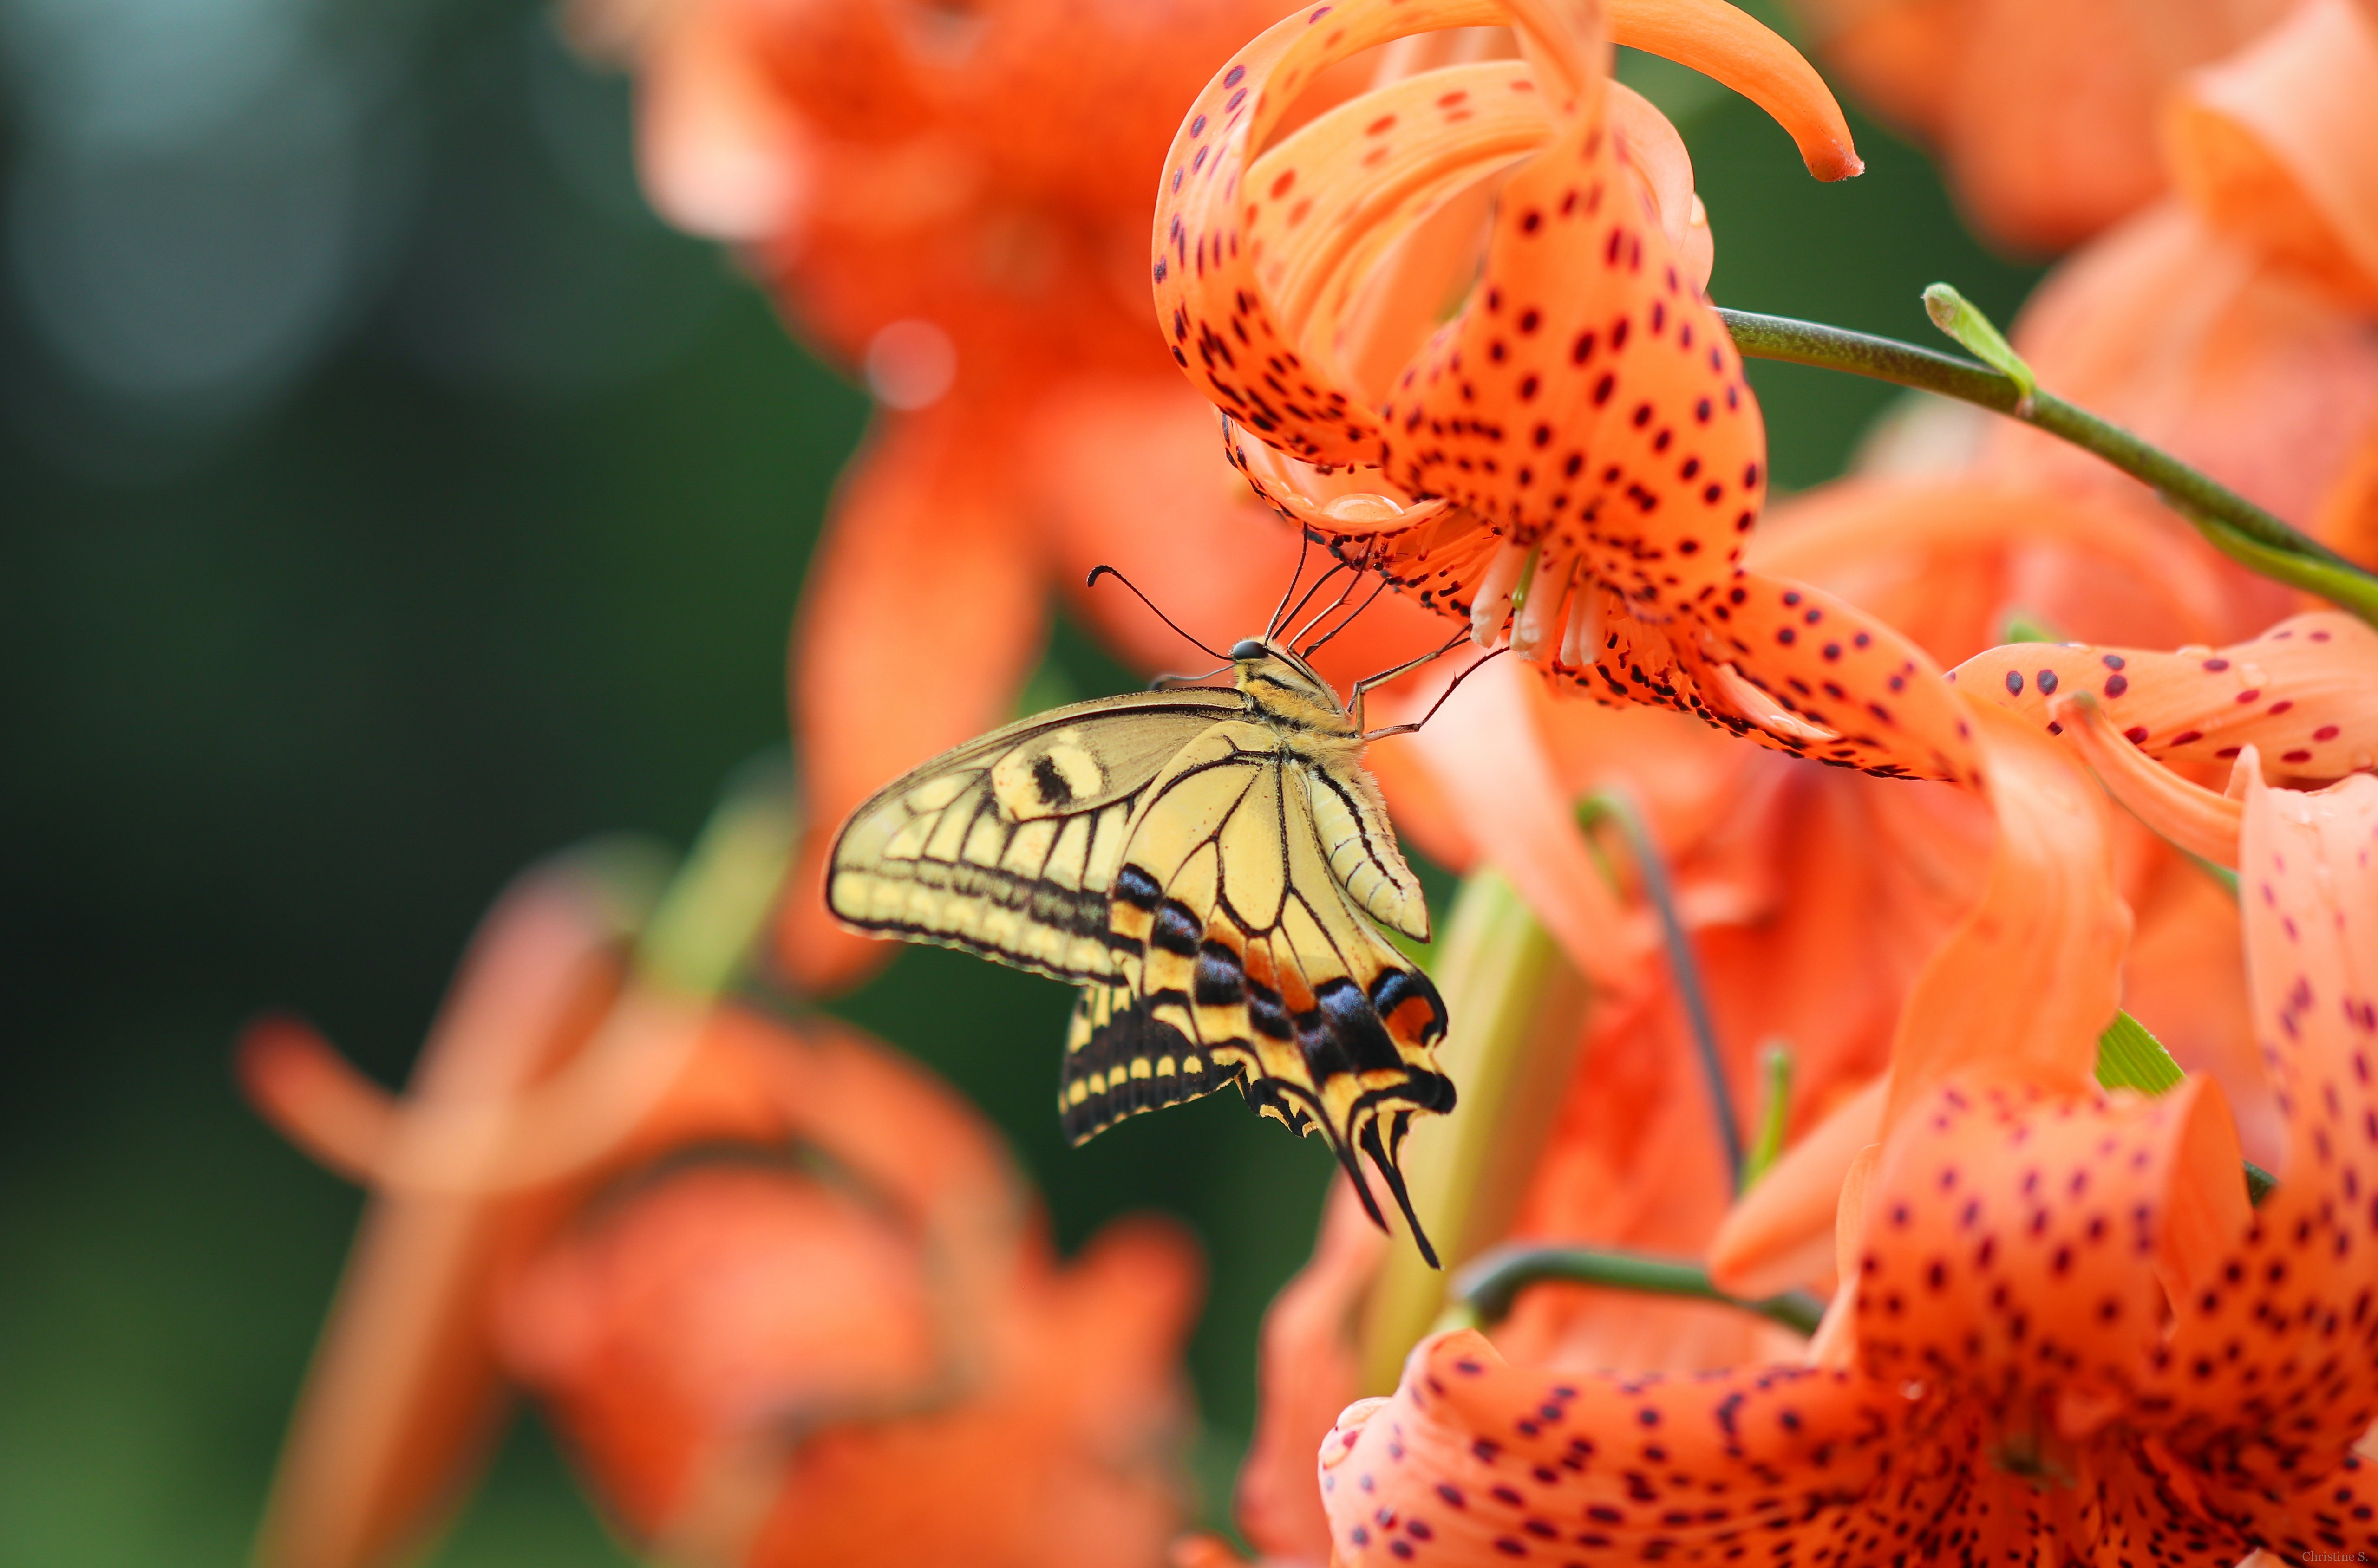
left=2164, top=0, right=2378, bottom=306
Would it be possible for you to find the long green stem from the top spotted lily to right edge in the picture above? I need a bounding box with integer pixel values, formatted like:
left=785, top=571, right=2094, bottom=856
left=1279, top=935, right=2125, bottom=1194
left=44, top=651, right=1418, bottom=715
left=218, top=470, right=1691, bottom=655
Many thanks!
left=1717, top=309, right=2378, bottom=625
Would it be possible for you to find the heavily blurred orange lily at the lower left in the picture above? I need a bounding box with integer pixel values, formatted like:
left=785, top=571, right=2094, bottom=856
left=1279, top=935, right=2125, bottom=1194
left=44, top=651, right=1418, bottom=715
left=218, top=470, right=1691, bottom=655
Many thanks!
left=240, top=850, right=1198, bottom=1568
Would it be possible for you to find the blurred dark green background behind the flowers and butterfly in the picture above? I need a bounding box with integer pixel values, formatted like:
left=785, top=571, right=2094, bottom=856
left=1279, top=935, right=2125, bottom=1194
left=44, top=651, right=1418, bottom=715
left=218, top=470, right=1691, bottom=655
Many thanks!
left=0, top=0, right=2031, bottom=1568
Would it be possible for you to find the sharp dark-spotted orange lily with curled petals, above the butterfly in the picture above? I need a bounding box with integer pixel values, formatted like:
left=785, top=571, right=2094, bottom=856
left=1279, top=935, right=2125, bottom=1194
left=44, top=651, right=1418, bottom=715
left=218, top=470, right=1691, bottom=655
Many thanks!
left=1151, top=0, right=2007, bottom=779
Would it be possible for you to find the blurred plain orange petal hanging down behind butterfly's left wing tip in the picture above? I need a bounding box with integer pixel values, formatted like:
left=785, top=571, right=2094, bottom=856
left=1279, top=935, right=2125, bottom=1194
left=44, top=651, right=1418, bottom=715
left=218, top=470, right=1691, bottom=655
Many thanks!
left=777, top=409, right=1046, bottom=991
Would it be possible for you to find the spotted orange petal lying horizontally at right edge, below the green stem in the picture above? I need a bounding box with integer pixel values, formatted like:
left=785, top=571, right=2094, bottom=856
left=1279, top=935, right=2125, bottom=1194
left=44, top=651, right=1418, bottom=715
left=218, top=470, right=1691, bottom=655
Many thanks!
left=1950, top=611, right=2378, bottom=779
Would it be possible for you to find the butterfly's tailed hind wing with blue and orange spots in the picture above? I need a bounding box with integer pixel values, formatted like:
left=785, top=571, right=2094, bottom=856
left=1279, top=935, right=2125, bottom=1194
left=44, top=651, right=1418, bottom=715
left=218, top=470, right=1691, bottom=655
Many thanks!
left=1058, top=722, right=1453, bottom=1264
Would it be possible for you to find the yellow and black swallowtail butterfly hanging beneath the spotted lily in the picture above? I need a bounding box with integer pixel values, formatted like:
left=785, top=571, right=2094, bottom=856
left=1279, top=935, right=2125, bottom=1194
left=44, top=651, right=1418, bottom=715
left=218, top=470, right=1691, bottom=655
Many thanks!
left=828, top=639, right=1453, bottom=1262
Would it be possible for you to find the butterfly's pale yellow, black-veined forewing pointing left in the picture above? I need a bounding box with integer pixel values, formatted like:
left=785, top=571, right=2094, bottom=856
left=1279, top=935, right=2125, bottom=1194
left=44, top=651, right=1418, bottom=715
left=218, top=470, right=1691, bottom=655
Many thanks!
left=825, top=689, right=1246, bottom=981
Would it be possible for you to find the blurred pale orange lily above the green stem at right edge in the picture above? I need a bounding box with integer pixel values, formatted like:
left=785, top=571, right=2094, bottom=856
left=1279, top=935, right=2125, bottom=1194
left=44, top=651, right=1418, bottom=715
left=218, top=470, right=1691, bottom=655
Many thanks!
left=1981, top=0, right=2378, bottom=560
